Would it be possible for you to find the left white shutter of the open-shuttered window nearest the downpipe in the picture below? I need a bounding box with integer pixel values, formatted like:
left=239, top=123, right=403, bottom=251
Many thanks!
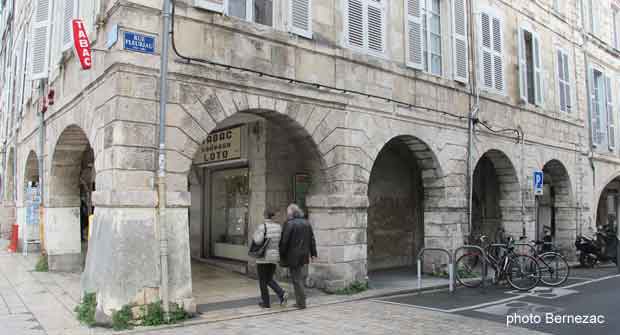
left=405, top=0, right=424, bottom=70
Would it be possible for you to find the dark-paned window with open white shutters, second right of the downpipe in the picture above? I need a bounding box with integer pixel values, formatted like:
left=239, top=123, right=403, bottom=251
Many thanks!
left=519, top=27, right=543, bottom=106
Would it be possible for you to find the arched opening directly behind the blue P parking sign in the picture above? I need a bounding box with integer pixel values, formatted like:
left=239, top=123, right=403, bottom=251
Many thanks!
left=537, top=159, right=577, bottom=249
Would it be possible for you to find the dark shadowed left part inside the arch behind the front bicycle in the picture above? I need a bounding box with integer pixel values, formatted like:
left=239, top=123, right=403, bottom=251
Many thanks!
left=471, top=155, right=502, bottom=243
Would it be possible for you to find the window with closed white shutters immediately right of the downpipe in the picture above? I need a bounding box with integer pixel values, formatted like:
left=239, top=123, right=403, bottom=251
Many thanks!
left=480, top=11, right=504, bottom=94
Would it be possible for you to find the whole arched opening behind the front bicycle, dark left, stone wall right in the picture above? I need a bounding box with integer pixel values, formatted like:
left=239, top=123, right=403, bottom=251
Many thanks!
left=470, top=149, right=523, bottom=242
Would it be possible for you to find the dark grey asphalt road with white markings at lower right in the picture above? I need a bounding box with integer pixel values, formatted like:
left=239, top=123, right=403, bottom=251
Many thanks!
left=378, top=265, right=620, bottom=335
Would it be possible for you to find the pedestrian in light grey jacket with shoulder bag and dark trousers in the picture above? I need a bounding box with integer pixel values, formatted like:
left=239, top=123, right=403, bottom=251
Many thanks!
left=253, top=210, right=288, bottom=308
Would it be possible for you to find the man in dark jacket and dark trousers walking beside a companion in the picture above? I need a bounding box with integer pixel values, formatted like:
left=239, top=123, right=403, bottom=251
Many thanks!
left=280, top=204, right=317, bottom=309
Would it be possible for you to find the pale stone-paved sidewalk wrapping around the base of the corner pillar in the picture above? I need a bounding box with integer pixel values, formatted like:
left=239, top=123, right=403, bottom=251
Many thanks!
left=0, top=243, right=537, bottom=335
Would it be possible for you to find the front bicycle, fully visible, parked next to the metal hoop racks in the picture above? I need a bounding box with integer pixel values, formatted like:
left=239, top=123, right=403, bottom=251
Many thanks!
left=456, top=235, right=541, bottom=291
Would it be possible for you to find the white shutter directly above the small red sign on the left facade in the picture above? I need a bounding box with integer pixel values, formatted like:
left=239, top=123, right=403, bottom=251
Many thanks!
left=30, top=0, right=52, bottom=80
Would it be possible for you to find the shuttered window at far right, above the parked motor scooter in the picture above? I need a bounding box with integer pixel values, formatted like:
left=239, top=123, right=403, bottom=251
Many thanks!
left=589, top=68, right=616, bottom=150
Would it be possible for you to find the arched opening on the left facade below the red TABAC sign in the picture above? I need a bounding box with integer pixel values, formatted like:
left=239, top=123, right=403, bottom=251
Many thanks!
left=45, top=124, right=95, bottom=271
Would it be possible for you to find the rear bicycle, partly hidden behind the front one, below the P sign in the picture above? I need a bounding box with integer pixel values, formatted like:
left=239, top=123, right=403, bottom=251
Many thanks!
left=530, top=241, right=570, bottom=286
